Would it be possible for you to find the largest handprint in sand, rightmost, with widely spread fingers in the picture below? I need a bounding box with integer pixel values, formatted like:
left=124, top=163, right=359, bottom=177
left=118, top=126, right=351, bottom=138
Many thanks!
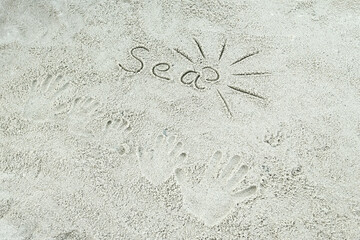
left=175, top=151, right=257, bottom=226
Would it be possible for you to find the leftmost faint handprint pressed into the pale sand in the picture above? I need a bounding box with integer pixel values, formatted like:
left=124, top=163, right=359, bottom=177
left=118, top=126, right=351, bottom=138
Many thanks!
left=23, top=75, right=70, bottom=122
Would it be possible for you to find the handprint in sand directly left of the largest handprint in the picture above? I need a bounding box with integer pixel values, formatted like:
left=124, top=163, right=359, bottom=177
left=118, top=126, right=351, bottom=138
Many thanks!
left=138, top=135, right=187, bottom=185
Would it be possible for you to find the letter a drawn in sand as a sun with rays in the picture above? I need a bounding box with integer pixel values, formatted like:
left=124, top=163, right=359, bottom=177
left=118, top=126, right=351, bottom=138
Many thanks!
left=174, top=38, right=270, bottom=117
